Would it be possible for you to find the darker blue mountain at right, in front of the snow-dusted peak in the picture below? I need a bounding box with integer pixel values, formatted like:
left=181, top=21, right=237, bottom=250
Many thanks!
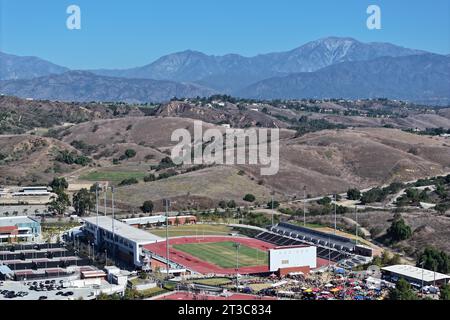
left=236, top=54, right=450, bottom=104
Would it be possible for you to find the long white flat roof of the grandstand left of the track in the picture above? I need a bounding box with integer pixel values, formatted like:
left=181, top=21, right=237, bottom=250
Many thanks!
left=83, top=216, right=162, bottom=244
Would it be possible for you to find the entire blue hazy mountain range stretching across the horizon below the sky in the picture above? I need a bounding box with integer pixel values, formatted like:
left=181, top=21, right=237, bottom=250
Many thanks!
left=0, top=37, right=450, bottom=104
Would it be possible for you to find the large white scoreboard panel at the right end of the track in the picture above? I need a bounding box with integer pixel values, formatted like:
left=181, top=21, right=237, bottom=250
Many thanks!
left=269, top=246, right=317, bottom=272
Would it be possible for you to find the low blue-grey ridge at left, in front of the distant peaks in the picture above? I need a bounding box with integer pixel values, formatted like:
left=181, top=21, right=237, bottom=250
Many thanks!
left=0, top=71, right=214, bottom=103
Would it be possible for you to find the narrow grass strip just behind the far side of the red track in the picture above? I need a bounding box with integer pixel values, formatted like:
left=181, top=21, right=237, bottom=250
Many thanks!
left=149, top=224, right=231, bottom=237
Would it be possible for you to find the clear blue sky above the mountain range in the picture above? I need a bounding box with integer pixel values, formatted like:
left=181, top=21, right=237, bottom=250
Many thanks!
left=0, top=0, right=450, bottom=69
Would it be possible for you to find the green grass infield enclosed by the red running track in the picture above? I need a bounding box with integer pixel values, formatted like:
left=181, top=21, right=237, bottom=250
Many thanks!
left=173, top=241, right=268, bottom=268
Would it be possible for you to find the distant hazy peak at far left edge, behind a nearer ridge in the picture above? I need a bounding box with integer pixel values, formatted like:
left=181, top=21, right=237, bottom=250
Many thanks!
left=0, top=52, right=69, bottom=80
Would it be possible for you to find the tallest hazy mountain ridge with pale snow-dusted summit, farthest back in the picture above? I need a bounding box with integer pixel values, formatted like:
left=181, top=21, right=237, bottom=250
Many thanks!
left=92, top=37, right=423, bottom=92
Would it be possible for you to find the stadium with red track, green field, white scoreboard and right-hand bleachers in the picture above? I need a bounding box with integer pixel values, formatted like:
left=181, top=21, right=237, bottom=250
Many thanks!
left=143, top=224, right=368, bottom=275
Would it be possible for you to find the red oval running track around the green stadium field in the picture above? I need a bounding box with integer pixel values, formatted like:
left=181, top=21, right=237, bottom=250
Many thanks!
left=144, top=236, right=276, bottom=275
